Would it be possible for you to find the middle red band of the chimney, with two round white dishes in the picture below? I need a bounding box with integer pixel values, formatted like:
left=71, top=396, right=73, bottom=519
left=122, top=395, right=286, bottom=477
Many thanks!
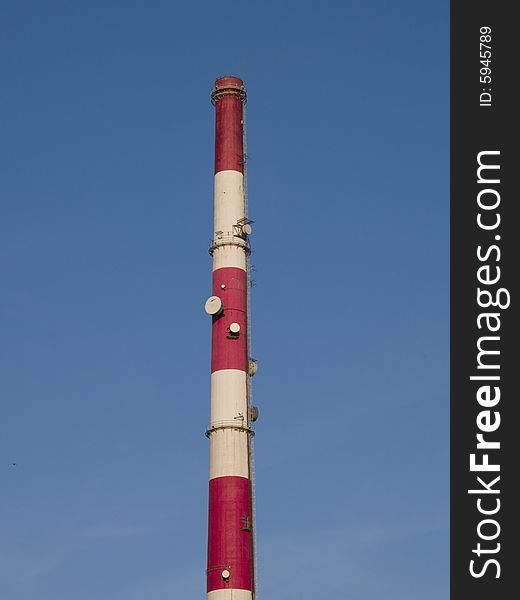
left=211, top=267, right=248, bottom=373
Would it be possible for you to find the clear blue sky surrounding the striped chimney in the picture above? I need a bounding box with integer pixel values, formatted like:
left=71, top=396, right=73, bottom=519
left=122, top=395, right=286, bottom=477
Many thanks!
left=0, top=0, right=449, bottom=600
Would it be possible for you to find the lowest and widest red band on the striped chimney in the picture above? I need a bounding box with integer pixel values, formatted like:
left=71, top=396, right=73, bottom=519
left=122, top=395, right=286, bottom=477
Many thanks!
left=207, top=477, right=253, bottom=592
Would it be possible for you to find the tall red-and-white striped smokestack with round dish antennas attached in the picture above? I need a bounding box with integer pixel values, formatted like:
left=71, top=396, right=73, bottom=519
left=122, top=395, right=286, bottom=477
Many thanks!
left=205, top=77, right=257, bottom=600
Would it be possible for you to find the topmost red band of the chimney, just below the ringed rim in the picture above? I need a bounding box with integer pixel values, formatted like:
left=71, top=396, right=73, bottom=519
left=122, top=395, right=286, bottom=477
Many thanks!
left=215, top=96, right=244, bottom=173
